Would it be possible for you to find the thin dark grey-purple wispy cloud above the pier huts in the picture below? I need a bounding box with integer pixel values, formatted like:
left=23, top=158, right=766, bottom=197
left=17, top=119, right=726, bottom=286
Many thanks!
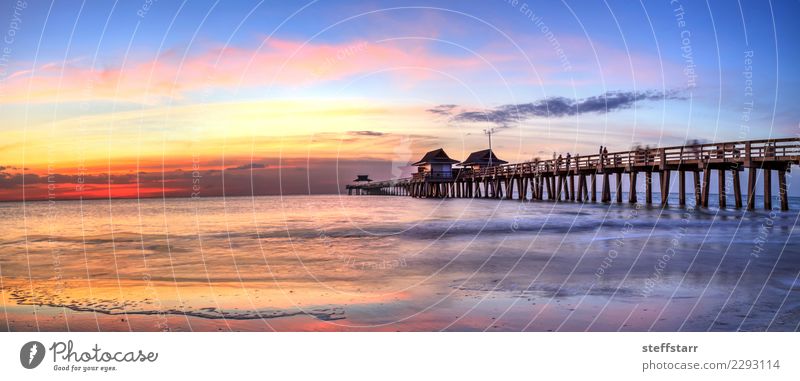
left=434, top=90, right=685, bottom=126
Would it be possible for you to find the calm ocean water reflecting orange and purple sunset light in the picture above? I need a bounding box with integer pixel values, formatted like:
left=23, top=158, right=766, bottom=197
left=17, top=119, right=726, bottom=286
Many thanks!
left=0, top=195, right=800, bottom=331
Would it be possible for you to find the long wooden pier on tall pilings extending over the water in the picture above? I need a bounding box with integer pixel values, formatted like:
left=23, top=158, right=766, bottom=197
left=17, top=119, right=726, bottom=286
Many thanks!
left=346, top=138, right=800, bottom=210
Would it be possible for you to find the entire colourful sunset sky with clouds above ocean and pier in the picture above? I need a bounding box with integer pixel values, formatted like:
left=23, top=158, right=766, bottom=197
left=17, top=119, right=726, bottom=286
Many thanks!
left=0, top=0, right=800, bottom=201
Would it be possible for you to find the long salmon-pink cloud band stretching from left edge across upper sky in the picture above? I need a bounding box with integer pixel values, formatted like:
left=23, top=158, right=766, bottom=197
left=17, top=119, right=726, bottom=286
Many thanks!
left=4, top=39, right=496, bottom=103
